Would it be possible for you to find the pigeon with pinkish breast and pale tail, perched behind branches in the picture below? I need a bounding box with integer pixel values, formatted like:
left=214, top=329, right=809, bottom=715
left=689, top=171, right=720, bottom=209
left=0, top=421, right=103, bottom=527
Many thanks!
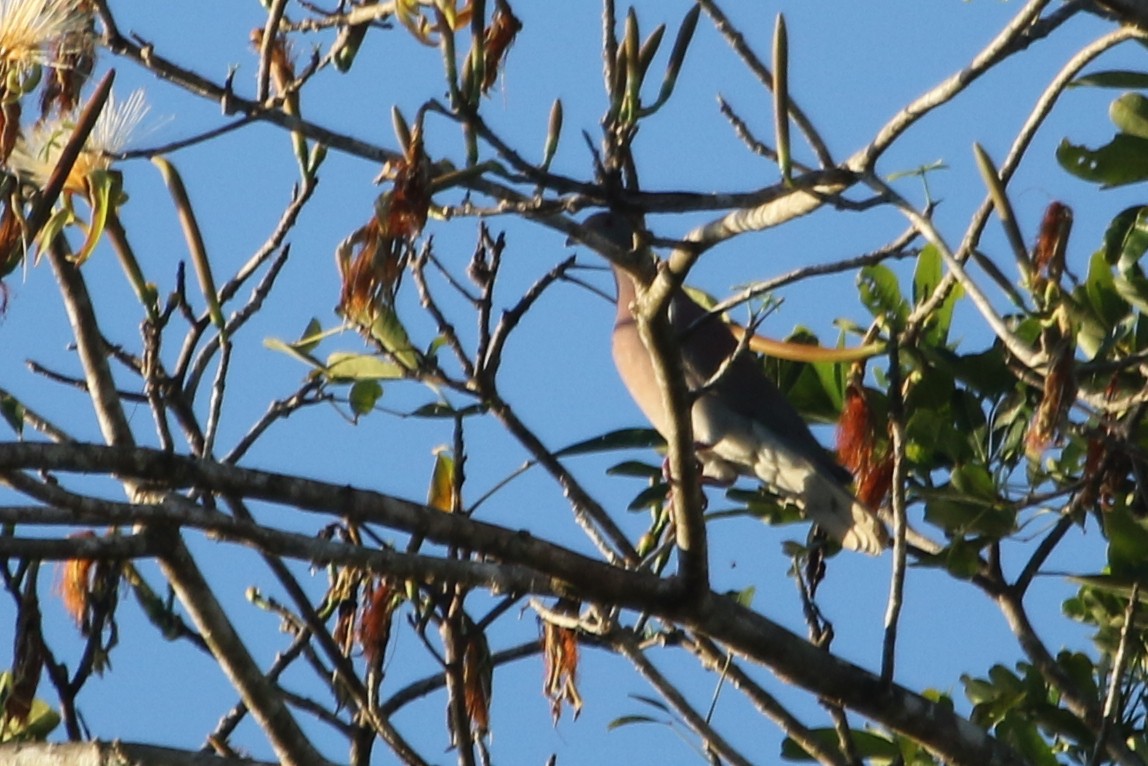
left=585, top=212, right=887, bottom=554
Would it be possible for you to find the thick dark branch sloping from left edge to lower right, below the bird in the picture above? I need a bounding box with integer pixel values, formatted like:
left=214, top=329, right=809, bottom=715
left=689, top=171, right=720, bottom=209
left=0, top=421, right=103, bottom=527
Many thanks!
left=0, top=442, right=1023, bottom=766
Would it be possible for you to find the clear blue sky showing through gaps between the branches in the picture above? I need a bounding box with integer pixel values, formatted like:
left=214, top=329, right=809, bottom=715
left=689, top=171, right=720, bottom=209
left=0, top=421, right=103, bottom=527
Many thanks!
left=0, top=0, right=1141, bottom=764
